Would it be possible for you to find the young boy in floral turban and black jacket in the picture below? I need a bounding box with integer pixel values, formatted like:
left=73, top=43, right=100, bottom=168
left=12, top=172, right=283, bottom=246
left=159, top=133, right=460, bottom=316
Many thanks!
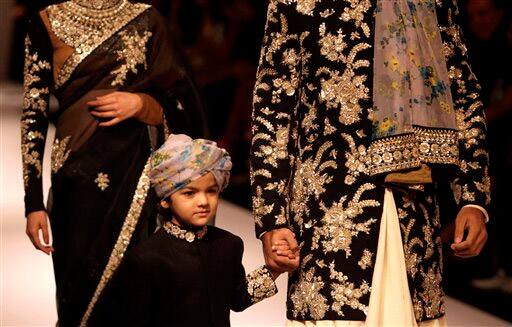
left=107, top=135, right=286, bottom=326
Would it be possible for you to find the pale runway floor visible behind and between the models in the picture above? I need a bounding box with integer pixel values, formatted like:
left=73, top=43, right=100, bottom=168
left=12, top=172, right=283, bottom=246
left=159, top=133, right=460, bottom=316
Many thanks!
left=0, top=84, right=512, bottom=326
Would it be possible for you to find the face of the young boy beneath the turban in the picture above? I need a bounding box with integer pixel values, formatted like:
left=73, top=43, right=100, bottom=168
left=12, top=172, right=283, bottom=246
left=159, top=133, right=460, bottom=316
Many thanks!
left=161, top=173, right=219, bottom=227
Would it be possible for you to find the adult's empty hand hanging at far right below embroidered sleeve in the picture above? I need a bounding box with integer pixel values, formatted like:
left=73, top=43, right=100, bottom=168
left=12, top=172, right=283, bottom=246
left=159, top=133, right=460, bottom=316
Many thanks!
left=451, top=207, right=487, bottom=258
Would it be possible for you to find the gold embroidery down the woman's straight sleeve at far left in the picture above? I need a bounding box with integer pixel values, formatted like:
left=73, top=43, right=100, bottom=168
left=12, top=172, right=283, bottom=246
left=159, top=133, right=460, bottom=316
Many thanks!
left=21, top=36, right=51, bottom=186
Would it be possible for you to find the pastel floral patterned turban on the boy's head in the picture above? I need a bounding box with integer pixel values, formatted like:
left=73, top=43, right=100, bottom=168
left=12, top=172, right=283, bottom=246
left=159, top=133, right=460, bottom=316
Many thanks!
left=150, top=134, right=232, bottom=199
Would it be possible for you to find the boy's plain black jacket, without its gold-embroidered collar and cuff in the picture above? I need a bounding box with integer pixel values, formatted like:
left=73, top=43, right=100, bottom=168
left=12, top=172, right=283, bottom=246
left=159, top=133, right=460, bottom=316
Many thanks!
left=90, top=226, right=253, bottom=327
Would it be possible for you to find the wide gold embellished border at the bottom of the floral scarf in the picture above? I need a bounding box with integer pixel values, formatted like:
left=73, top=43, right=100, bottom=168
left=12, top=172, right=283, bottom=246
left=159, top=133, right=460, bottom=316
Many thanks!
left=368, top=126, right=459, bottom=175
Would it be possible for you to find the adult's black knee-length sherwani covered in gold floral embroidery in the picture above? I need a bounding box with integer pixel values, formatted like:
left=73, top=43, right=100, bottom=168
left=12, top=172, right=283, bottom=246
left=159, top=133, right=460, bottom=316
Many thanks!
left=251, top=0, right=490, bottom=321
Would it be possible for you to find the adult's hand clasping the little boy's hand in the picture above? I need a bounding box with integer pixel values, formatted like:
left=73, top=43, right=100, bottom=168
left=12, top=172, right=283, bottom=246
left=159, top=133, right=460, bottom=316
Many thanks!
left=261, top=228, right=300, bottom=273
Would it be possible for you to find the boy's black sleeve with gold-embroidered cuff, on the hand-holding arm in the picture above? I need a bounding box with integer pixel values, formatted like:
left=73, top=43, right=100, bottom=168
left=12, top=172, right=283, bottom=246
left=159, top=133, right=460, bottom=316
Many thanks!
left=231, top=239, right=277, bottom=312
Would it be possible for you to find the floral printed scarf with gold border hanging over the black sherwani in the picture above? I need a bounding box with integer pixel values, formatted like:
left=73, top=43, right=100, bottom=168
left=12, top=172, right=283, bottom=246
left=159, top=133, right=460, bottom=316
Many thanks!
left=370, top=0, right=458, bottom=174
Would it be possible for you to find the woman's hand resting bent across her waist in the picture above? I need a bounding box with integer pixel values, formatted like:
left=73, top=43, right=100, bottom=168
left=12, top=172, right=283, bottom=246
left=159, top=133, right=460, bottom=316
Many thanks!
left=87, top=91, right=143, bottom=127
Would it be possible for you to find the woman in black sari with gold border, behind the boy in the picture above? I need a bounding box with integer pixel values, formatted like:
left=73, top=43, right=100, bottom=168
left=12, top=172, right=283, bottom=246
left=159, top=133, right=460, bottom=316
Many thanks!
left=21, top=0, right=205, bottom=326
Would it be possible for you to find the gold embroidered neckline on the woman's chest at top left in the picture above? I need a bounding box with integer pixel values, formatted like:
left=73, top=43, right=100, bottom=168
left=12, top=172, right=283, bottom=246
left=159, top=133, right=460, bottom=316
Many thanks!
left=47, top=0, right=150, bottom=88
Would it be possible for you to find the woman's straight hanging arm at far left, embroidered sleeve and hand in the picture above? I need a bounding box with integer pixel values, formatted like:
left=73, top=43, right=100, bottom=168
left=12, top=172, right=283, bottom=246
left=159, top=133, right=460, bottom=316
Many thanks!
left=21, top=15, right=53, bottom=254
